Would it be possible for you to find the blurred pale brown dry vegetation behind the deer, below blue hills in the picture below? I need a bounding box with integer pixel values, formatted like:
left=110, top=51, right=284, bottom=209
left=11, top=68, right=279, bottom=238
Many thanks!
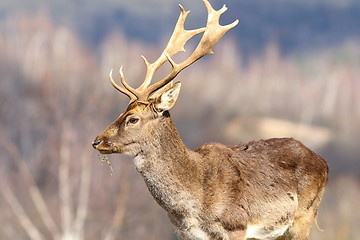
left=0, top=12, right=360, bottom=240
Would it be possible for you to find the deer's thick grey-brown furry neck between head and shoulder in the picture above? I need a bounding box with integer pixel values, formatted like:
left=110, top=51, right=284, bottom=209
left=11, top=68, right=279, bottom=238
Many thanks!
left=134, top=114, right=198, bottom=210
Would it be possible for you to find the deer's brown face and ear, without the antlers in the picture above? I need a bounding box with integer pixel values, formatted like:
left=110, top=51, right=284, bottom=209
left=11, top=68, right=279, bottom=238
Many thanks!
left=93, top=83, right=181, bottom=155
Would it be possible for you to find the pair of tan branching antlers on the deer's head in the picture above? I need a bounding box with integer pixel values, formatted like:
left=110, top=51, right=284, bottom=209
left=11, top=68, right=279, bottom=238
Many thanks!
left=109, top=0, right=239, bottom=103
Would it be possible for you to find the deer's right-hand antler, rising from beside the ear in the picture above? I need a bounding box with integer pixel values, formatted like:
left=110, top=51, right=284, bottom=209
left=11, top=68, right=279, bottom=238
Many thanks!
left=143, top=0, right=239, bottom=97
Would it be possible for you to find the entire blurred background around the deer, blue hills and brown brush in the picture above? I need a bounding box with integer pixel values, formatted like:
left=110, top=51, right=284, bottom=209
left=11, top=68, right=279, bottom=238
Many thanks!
left=0, top=0, right=360, bottom=240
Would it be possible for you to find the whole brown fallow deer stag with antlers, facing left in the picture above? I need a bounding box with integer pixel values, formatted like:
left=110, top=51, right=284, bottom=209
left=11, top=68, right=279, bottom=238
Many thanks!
left=92, top=0, right=328, bottom=240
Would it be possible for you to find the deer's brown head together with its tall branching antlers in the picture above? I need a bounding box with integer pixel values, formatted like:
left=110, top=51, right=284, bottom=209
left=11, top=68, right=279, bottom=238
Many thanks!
left=92, top=0, right=239, bottom=155
